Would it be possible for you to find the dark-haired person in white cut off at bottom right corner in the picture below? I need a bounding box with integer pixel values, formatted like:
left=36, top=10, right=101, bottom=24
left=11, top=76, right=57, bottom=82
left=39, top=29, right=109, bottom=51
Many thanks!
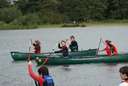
left=119, top=66, right=128, bottom=86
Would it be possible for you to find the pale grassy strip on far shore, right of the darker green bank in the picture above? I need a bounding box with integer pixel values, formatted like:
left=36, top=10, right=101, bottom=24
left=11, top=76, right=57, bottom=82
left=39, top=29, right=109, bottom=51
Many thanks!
left=39, top=20, right=128, bottom=28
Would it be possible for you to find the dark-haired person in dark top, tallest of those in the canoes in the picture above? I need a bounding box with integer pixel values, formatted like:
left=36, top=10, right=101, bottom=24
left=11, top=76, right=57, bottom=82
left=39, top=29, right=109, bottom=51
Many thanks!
left=69, top=35, right=78, bottom=52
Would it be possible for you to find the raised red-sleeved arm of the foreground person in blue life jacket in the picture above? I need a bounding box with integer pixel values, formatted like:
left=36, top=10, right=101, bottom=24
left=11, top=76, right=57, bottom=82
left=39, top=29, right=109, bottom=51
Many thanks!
left=28, top=61, right=43, bottom=84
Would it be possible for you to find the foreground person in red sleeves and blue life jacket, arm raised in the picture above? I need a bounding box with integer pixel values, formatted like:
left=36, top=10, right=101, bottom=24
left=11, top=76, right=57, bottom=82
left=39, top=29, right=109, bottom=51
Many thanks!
left=28, top=60, right=54, bottom=86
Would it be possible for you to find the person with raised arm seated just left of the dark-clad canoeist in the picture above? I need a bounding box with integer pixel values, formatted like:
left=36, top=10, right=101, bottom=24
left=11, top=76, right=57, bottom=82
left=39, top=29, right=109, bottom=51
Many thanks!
left=55, top=40, right=68, bottom=57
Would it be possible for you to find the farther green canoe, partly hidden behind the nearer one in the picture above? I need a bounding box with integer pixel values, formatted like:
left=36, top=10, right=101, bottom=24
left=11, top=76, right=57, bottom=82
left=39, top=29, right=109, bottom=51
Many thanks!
left=11, top=49, right=97, bottom=61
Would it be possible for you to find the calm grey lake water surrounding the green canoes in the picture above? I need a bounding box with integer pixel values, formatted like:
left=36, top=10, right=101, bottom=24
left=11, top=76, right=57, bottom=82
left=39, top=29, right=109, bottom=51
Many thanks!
left=0, top=26, right=128, bottom=86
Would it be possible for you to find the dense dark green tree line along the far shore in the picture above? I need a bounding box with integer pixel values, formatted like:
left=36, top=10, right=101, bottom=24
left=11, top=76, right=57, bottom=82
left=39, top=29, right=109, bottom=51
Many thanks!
left=0, top=0, right=128, bottom=25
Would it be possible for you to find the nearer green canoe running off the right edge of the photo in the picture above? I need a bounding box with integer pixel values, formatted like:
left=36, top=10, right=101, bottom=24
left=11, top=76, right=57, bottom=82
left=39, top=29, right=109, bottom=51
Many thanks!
left=37, top=53, right=128, bottom=66
